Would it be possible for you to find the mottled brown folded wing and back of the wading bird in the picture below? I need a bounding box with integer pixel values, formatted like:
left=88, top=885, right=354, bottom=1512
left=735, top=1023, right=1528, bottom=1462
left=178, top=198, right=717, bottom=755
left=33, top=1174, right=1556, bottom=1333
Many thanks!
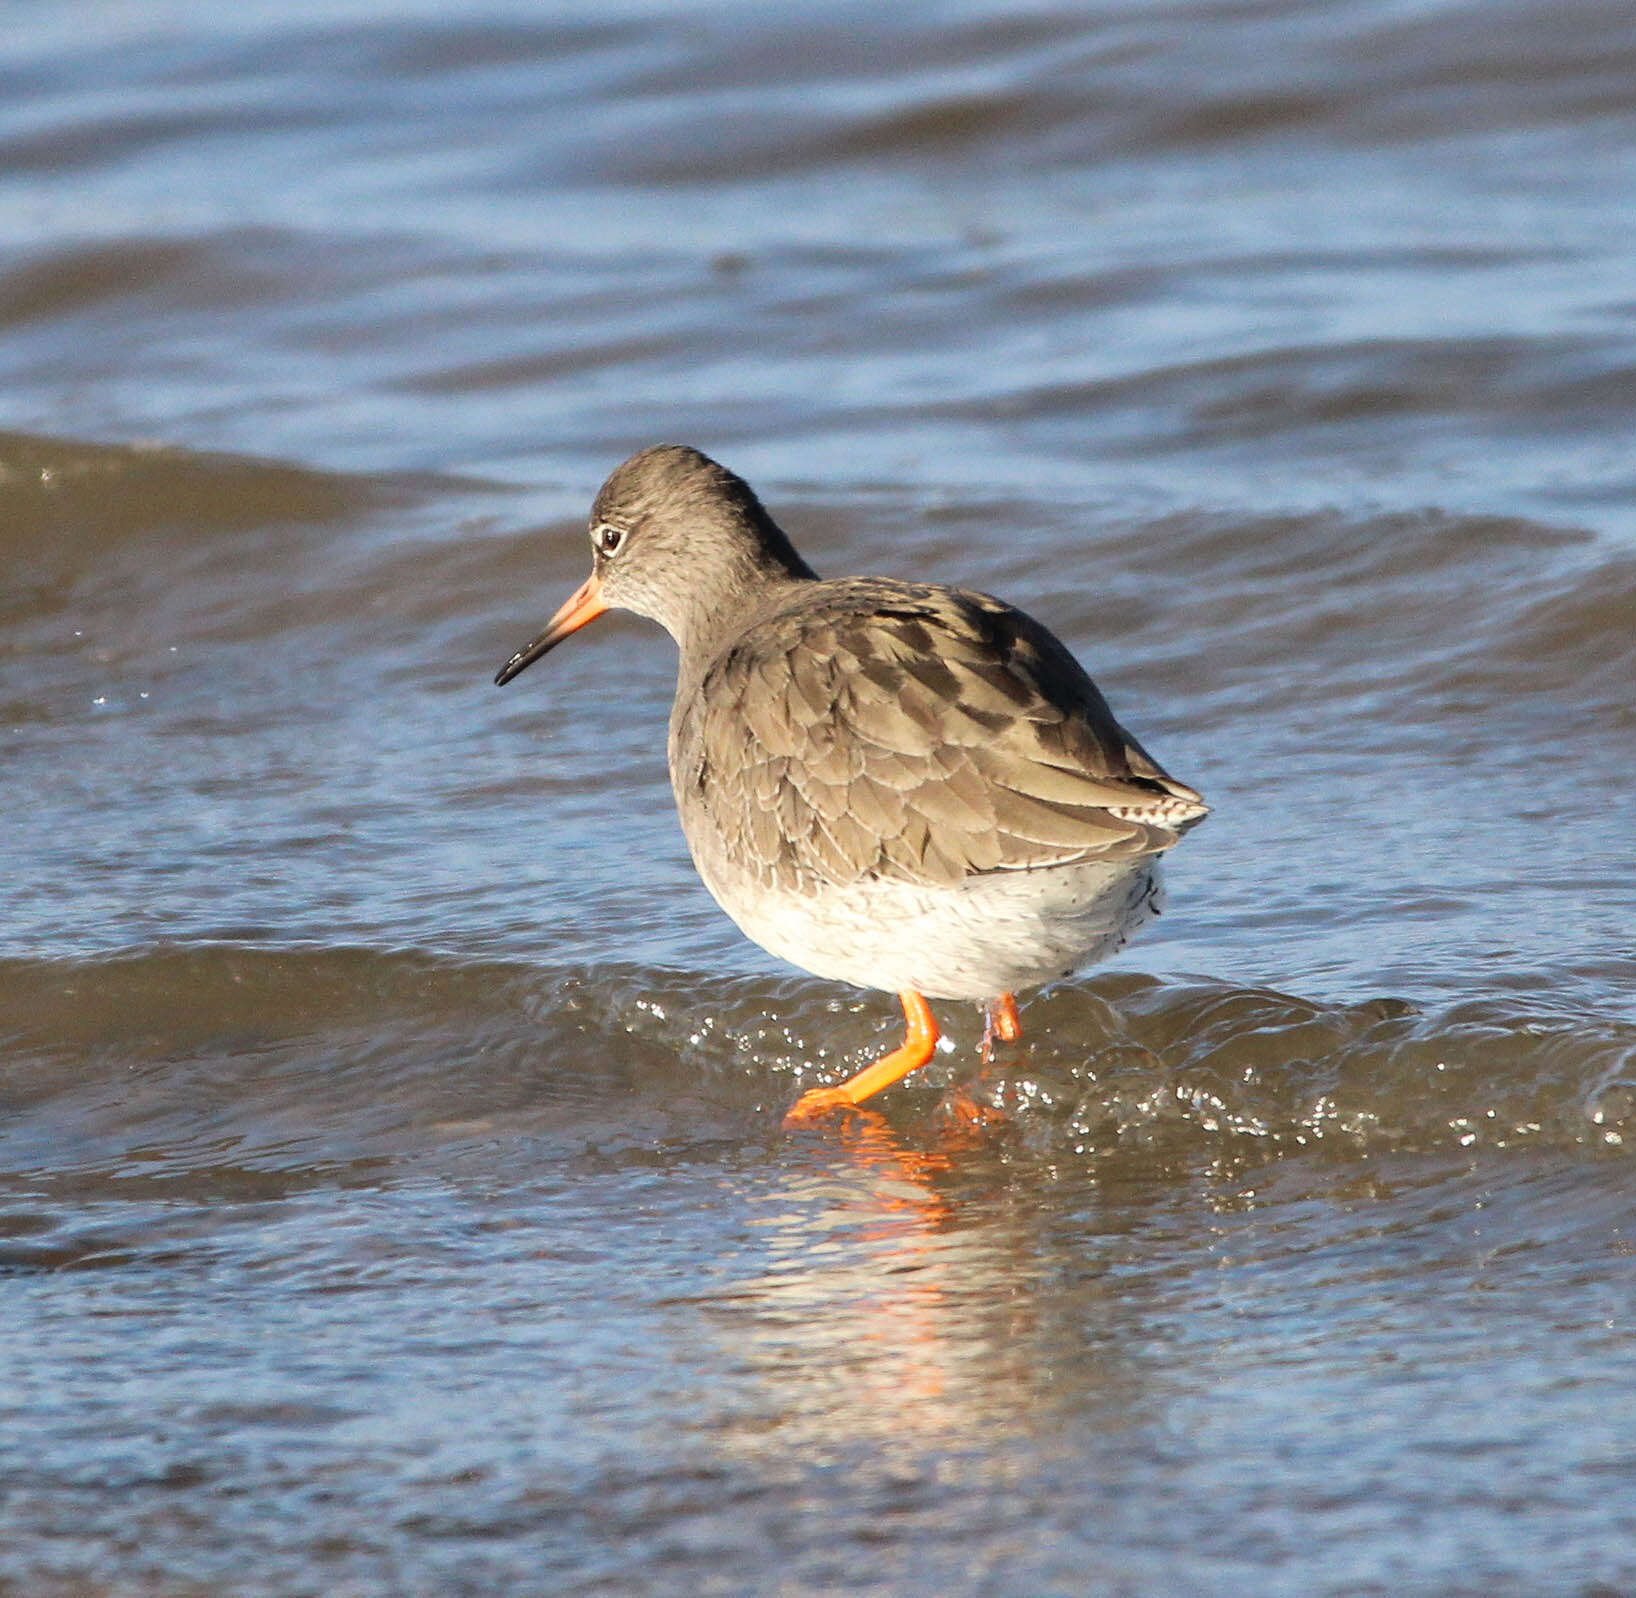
left=676, top=577, right=1206, bottom=888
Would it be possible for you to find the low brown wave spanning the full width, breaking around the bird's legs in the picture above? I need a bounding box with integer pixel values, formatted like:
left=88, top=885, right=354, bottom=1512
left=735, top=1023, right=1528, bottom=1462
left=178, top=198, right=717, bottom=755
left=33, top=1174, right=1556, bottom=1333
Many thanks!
left=0, top=945, right=1636, bottom=1174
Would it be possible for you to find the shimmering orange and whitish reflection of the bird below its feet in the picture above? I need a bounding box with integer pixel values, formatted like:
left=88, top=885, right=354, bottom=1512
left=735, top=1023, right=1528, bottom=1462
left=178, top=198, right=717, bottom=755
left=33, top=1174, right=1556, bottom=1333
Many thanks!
left=664, top=1079, right=1137, bottom=1537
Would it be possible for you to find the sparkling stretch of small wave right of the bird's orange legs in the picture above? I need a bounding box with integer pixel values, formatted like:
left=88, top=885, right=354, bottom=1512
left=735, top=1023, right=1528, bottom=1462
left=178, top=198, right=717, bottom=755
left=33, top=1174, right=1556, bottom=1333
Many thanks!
left=998, top=978, right=1636, bottom=1155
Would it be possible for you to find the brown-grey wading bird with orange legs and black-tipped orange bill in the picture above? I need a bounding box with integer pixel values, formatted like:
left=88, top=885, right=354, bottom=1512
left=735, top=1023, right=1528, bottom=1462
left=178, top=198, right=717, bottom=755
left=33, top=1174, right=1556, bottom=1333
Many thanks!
left=494, top=445, right=1209, bottom=1124
